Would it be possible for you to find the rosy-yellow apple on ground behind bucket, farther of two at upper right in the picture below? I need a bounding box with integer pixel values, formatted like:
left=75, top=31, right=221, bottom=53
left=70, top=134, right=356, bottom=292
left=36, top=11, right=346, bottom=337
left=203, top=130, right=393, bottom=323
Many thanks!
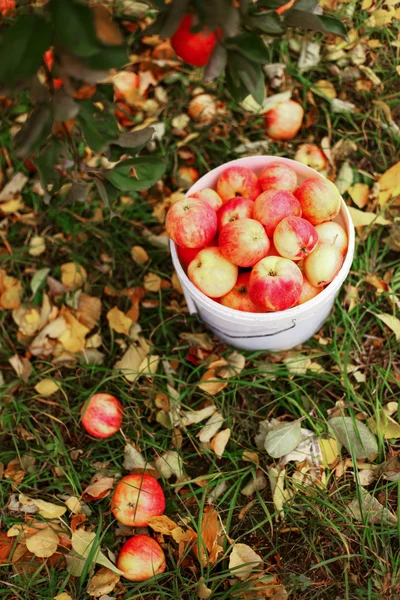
left=264, top=100, right=304, bottom=140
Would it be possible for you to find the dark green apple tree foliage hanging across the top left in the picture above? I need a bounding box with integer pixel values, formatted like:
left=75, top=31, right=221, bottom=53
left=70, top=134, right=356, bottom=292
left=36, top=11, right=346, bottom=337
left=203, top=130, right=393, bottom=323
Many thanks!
left=0, top=0, right=346, bottom=204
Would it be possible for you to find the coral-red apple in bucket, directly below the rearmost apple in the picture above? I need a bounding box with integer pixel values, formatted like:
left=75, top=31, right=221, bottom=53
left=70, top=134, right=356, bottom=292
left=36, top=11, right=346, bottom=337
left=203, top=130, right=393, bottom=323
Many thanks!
left=253, top=190, right=301, bottom=237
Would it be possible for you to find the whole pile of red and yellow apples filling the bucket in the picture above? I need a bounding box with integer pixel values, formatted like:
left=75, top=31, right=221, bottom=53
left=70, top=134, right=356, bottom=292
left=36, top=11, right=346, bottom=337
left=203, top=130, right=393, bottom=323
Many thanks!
left=166, top=161, right=348, bottom=313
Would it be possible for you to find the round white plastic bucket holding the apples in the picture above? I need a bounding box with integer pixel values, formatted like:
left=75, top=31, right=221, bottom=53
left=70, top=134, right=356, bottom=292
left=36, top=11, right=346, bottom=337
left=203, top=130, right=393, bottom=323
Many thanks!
left=171, top=156, right=355, bottom=351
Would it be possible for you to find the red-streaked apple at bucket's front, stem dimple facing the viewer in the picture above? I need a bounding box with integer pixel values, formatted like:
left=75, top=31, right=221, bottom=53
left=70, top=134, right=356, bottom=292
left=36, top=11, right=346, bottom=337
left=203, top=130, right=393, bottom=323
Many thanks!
left=249, top=256, right=303, bottom=310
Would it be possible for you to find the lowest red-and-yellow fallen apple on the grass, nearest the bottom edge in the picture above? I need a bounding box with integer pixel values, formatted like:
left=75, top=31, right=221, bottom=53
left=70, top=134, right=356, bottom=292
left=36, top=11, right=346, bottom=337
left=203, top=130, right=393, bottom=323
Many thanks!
left=117, top=535, right=167, bottom=581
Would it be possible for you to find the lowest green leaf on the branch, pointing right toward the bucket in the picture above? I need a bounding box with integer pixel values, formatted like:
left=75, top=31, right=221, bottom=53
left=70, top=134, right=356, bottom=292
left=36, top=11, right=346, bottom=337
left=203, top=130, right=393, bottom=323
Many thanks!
left=105, top=156, right=167, bottom=192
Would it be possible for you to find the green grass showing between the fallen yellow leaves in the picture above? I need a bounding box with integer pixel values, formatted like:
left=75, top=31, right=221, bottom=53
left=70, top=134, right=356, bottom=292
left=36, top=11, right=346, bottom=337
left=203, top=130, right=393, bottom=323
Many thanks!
left=0, top=4, right=400, bottom=600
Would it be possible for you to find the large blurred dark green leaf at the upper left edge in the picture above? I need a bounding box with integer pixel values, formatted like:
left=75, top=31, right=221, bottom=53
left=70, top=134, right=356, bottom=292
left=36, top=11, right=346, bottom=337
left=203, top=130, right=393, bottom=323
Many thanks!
left=0, top=13, right=51, bottom=84
